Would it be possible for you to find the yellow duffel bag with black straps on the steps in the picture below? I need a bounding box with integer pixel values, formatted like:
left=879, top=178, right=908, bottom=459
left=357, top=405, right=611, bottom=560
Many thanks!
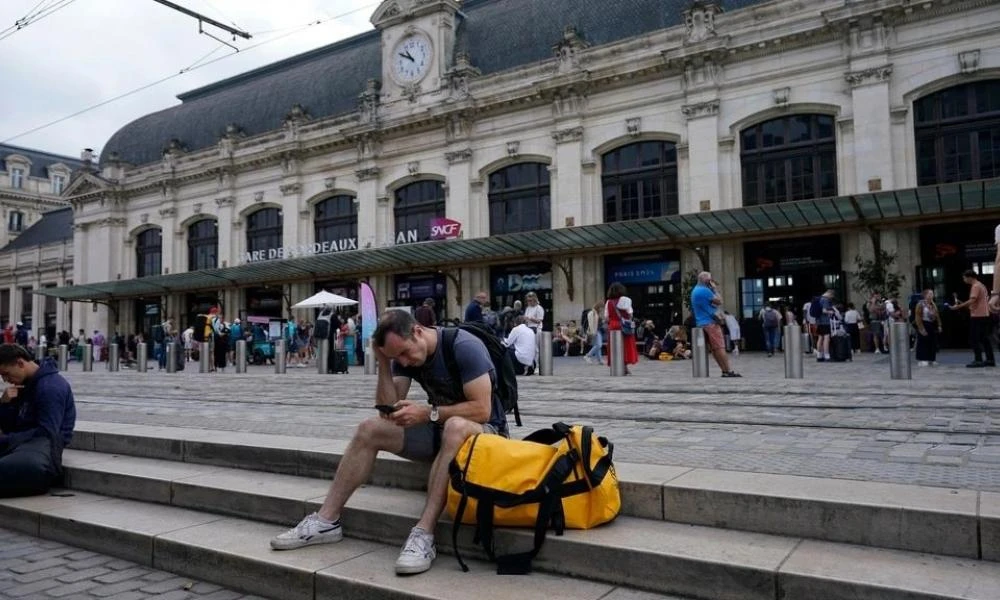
left=448, top=423, right=621, bottom=574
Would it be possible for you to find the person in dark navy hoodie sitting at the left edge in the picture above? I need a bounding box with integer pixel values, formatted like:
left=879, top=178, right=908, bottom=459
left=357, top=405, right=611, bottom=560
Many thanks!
left=0, top=344, right=76, bottom=498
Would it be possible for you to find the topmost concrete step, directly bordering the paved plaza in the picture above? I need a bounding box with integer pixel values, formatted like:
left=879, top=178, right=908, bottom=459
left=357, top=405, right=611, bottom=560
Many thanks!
left=72, top=422, right=1000, bottom=561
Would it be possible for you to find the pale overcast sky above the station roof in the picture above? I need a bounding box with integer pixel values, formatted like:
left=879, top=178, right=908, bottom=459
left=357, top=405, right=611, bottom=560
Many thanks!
left=0, top=0, right=379, bottom=157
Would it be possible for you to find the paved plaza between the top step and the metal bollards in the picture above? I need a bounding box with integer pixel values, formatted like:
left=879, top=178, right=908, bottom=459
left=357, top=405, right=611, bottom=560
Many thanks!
left=62, top=352, right=1000, bottom=491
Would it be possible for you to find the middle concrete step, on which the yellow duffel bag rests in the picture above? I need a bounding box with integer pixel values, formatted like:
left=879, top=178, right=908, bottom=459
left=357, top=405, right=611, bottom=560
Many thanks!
left=48, top=450, right=1000, bottom=600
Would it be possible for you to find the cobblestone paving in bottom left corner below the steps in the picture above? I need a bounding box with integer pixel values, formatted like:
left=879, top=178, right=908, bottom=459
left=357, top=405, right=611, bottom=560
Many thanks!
left=0, top=529, right=266, bottom=600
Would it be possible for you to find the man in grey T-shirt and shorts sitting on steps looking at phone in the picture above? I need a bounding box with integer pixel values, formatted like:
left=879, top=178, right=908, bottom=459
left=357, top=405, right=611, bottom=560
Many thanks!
left=271, top=310, right=507, bottom=575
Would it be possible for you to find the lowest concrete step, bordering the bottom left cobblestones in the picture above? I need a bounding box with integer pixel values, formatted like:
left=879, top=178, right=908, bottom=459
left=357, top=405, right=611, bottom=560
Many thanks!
left=0, top=492, right=664, bottom=600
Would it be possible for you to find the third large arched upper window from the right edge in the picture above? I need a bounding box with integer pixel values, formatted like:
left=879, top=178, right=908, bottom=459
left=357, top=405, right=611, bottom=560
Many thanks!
left=601, top=142, right=678, bottom=223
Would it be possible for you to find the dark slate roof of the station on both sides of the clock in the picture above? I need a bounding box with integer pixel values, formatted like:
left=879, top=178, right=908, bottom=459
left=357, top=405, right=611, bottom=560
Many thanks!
left=101, top=0, right=766, bottom=169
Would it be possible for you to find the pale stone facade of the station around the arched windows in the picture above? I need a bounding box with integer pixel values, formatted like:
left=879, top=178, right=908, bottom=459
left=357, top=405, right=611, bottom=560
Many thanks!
left=64, top=0, right=1000, bottom=340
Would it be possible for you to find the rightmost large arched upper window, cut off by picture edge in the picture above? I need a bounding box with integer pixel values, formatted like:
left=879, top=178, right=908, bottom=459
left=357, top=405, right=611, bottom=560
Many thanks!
left=913, top=79, right=1000, bottom=185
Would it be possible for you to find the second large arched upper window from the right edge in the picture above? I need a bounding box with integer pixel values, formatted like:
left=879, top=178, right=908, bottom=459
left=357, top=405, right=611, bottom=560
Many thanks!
left=740, top=115, right=837, bottom=206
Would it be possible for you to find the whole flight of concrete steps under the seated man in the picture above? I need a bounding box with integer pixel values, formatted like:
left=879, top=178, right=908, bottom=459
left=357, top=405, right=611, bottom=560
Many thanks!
left=0, top=423, right=1000, bottom=600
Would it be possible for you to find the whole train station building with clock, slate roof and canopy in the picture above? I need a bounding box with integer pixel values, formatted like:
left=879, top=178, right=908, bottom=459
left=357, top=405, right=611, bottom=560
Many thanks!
left=40, top=0, right=1000, bottom=350
